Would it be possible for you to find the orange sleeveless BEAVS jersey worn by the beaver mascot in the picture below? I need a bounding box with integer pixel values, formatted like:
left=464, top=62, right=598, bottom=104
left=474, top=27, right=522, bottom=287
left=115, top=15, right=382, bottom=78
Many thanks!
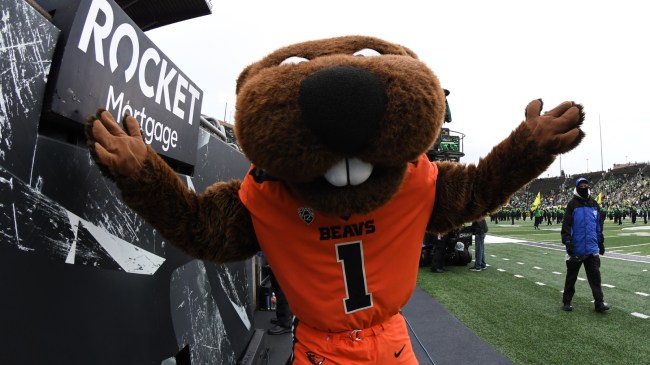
left=239, top=155, right=438, bottom=332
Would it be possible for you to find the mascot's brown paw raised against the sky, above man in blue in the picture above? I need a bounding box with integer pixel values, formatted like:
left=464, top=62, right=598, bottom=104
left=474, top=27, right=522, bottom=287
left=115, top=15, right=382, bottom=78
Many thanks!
left=526, top=99, right=585, bottom=154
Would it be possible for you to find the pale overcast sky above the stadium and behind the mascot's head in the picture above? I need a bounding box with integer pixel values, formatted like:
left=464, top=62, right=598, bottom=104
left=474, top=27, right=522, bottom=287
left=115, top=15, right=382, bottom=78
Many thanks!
left=147, top=0, right=650, bottom=177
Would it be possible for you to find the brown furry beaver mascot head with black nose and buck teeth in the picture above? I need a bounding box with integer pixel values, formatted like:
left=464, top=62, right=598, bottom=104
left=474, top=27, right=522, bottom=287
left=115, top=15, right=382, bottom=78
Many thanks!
left=235, top=36, right=445, bottom=216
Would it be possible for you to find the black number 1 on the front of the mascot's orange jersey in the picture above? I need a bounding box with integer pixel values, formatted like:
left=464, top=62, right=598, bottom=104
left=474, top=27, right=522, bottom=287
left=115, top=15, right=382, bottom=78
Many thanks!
left=336, top=241, right=372, bottom=313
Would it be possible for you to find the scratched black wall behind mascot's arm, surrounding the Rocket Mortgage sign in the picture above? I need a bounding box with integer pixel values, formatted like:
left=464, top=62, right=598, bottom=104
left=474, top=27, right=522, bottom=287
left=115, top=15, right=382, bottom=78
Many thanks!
left=0, top=0, right=253, bottom=365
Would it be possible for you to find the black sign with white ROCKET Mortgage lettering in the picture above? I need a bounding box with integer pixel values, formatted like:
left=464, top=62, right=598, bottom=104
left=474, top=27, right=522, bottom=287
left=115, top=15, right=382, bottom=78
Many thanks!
left=48, top=0, right=203, bottom=166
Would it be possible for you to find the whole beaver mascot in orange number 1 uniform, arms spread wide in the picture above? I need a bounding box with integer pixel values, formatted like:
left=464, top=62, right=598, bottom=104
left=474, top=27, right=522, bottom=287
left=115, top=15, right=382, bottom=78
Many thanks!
left=86, top=36, right=584, bottom=364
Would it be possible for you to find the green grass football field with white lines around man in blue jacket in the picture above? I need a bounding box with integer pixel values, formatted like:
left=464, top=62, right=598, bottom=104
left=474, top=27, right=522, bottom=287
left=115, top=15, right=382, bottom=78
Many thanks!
left=418, top=221, right=650, bottom=365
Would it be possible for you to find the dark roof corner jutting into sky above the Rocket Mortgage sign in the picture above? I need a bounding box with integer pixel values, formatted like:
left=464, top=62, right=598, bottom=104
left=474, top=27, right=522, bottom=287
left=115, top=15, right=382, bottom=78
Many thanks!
left=115, top=0, right=212, bottom=32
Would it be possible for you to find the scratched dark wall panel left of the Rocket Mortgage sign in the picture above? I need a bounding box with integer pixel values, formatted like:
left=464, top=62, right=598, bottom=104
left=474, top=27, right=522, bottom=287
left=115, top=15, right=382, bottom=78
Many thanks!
left=0, top=0, right=60, bottom=181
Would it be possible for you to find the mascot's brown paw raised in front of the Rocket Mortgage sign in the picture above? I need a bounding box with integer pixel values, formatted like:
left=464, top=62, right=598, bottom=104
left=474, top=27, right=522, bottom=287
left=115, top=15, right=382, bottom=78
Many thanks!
left=85, top=109, right=147, bottom=179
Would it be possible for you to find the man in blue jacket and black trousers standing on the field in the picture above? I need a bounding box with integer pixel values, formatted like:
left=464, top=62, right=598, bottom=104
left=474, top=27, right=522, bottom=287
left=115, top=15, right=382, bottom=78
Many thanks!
left=562, top=177, right=609, bottom=312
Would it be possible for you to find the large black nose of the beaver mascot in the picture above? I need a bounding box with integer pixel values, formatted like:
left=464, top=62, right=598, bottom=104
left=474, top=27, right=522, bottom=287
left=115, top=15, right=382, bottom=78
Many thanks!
left=298, top=66, right=388, bottom=155
